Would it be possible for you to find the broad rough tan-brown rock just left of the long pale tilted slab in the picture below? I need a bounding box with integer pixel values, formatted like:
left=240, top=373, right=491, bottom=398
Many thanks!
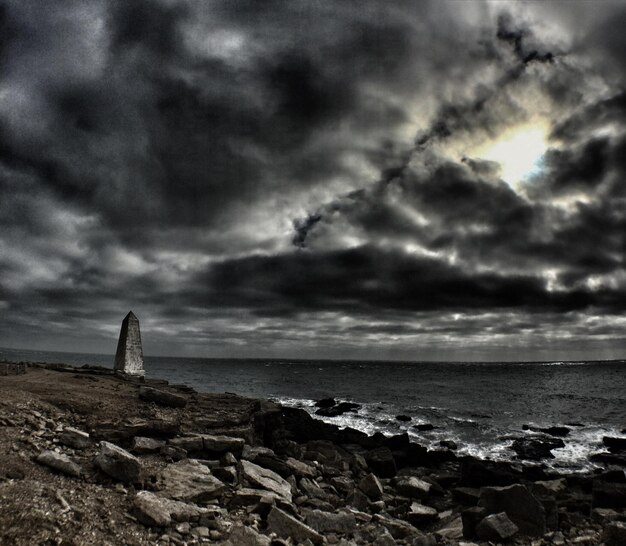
left=158, top=459, right=225, bottom=502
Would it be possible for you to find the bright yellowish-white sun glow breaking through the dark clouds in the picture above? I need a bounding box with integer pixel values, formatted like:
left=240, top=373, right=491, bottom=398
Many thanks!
left=471, top=123, right=548, bottom=185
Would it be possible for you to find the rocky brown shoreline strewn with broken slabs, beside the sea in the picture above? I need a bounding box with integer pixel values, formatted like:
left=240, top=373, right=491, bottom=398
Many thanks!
left=0, top=364, right=626, bottom=546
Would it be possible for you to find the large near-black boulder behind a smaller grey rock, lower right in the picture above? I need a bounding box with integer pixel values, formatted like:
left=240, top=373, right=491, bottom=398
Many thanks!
left=478, top=484, right=546, bottom=536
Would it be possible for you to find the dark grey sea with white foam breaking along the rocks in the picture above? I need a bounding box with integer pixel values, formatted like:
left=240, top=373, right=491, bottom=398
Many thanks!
left=0, top=348, right=626, bottom=471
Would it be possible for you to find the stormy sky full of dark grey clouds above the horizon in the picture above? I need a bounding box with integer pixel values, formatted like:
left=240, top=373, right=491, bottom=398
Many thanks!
left=0, top=0, right=626, bottom=360
